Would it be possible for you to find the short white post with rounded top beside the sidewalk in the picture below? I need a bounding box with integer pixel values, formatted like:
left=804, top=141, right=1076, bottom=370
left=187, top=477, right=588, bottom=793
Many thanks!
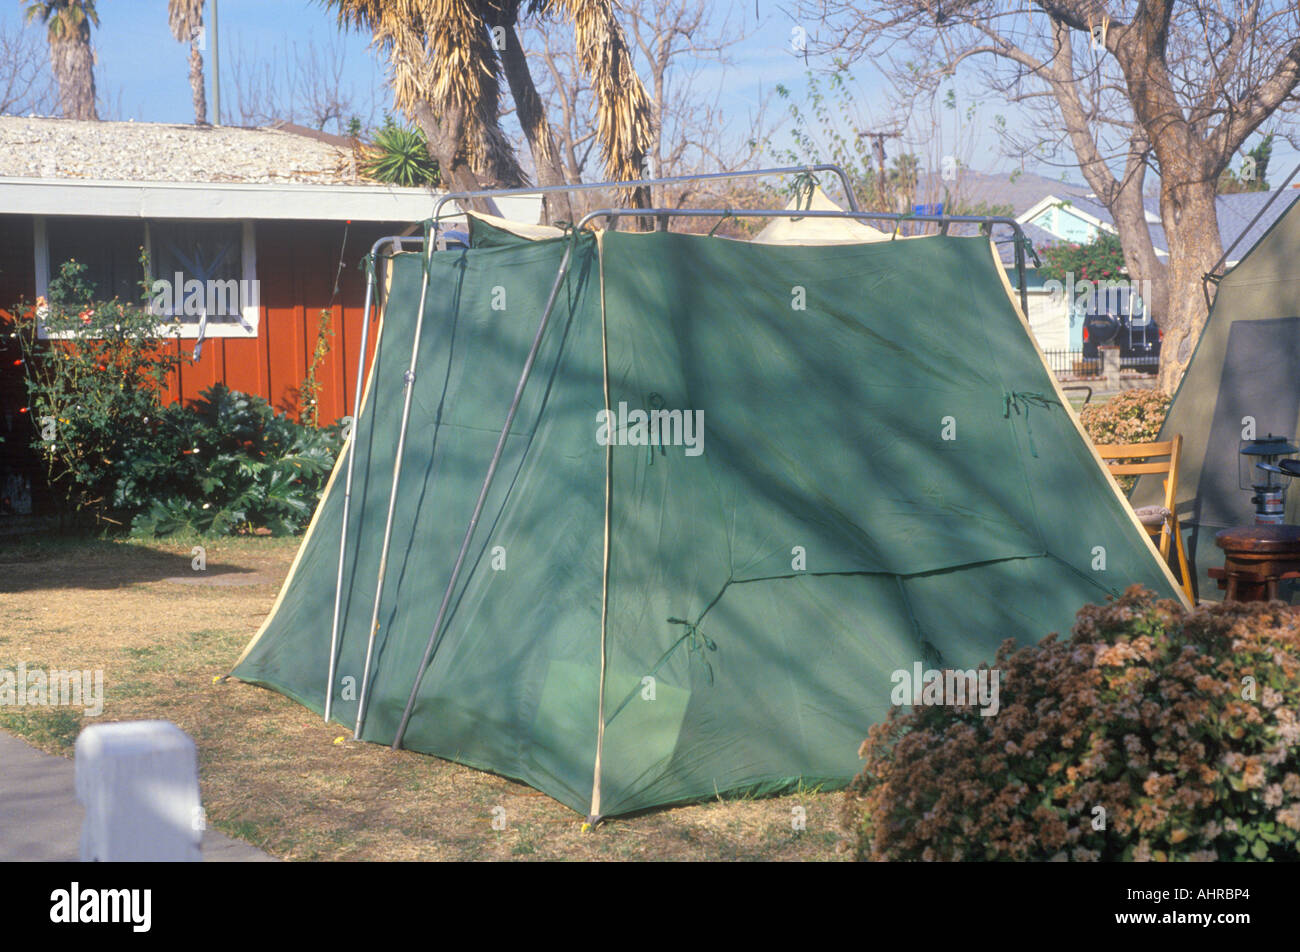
left=77, top=721, right=204, bottom=862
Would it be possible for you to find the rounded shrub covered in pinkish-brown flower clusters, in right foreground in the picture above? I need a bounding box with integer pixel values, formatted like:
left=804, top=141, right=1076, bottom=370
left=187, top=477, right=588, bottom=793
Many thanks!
left=842, top=587, right=1300, bottom=861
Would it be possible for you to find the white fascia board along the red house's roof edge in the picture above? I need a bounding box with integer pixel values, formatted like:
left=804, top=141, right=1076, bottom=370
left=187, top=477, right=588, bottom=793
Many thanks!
left=0, top=177, right=542, bottom=222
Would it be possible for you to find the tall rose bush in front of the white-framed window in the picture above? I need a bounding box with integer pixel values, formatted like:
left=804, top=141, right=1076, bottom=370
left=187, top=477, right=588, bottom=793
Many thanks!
left=14, top=251, right=182, bottom=522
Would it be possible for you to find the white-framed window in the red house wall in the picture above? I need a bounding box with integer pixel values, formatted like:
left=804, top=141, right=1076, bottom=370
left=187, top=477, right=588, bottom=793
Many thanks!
left=35, top=217, right=260, bottom=339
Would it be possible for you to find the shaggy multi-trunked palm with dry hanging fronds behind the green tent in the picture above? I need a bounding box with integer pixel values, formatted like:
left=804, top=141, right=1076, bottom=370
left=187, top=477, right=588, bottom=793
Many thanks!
left=324, top=0, right=654, bottom=205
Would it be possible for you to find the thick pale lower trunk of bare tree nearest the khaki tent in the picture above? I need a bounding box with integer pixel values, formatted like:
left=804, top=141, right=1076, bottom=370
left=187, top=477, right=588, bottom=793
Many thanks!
left=1157, top=170, right=1223, bottom=394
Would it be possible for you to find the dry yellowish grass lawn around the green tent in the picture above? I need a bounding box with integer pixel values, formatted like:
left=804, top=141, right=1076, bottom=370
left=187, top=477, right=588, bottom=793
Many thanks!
left=0, top=537, right=844, bottom=860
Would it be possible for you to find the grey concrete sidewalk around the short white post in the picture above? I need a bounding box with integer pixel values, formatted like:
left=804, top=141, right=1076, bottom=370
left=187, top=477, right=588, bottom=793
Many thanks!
left=0, top=731, right=276, bottom=862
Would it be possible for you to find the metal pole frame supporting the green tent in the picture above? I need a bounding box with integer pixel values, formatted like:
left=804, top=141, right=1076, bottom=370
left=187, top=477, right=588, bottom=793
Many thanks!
left=325, top=165, right=1032, bottom=749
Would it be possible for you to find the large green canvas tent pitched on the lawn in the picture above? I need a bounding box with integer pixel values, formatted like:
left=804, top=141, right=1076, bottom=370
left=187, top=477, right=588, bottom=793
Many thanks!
left=233, top=195, right=1180, bottom=818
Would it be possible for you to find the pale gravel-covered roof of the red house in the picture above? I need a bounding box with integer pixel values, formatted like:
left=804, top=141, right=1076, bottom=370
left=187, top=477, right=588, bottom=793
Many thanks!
left=0, top=116, right=361, bottom=185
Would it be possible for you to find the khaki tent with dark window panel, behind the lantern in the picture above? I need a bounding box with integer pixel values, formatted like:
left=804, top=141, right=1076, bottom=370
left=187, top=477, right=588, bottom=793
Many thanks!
left=1132, top=195, right=1300, bottom=600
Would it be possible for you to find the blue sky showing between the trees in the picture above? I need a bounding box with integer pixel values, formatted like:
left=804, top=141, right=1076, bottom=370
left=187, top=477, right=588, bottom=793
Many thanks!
left=0, top=0, right=1300, bottom=189
